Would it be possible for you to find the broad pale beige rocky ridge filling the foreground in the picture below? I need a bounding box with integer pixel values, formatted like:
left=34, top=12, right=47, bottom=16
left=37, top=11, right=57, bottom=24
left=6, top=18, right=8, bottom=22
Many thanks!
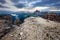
left=2, top=17, right=60, bottom=40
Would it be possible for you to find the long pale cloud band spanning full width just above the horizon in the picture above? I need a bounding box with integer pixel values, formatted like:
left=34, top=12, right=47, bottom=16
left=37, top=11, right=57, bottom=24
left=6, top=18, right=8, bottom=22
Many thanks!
left=0, top=7, right=60, bottom=12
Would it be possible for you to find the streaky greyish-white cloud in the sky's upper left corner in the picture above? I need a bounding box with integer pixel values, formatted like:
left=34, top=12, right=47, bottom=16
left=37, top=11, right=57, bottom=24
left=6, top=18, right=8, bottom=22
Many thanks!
left=0, top=0, right=18, bottom=12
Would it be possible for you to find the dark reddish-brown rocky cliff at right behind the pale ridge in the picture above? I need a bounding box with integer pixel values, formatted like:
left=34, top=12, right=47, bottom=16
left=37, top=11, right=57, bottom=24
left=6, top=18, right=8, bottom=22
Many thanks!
left=43, top=13, right=60, bottom=22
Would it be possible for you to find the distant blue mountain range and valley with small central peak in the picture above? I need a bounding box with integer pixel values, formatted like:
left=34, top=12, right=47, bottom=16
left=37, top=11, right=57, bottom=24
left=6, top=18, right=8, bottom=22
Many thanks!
left=0, top=10, right=60, bottom=22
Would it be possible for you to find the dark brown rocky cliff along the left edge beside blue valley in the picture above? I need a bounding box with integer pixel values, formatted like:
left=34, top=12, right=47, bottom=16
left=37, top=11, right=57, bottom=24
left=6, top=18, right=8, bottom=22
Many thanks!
left=0, top=15, right=13, bottom=39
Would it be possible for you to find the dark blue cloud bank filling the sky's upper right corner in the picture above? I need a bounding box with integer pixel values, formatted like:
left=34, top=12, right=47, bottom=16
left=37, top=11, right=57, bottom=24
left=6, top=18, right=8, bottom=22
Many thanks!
left=33, top=0, right=60, bottom=7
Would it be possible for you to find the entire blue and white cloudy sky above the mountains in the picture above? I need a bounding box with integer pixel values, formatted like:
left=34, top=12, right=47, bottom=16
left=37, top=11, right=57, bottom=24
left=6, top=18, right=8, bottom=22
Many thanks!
left=0, top=0, right=60, bottom=11
